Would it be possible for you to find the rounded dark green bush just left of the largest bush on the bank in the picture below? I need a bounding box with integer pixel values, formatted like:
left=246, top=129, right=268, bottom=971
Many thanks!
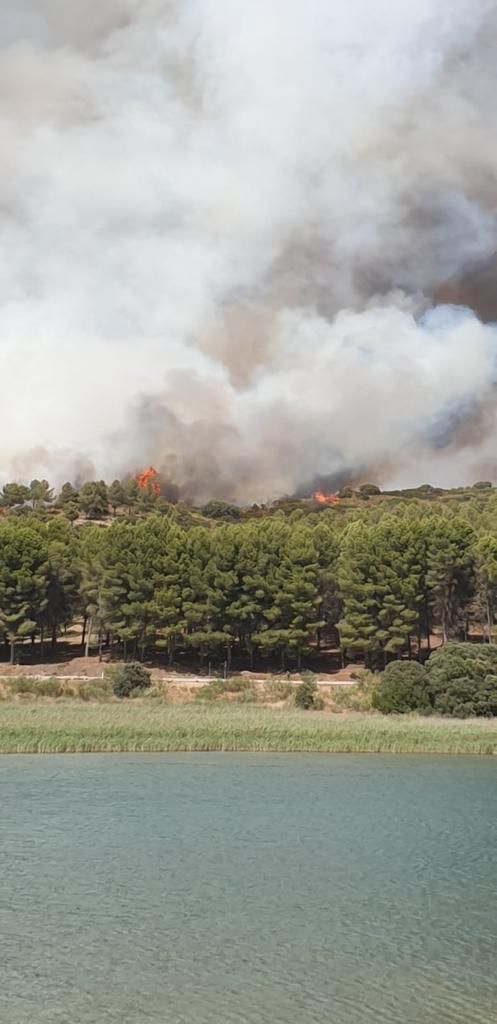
left=372, top=662, right=431, bottom=715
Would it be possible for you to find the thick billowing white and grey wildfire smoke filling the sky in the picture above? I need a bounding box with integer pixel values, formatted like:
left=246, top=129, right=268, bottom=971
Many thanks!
left=0, top=0, right=497, bottom=501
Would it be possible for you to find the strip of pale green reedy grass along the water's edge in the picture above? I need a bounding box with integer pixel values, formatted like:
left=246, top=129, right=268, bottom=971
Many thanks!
left=0, top=701, right=497, bottom=755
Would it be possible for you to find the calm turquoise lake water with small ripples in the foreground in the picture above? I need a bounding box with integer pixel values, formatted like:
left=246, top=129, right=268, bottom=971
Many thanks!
left=0, top=755, right=497, bottom=1024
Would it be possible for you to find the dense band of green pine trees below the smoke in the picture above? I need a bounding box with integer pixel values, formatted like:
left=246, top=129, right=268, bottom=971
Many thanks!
left=0, top=473, right=497, bottom=671
